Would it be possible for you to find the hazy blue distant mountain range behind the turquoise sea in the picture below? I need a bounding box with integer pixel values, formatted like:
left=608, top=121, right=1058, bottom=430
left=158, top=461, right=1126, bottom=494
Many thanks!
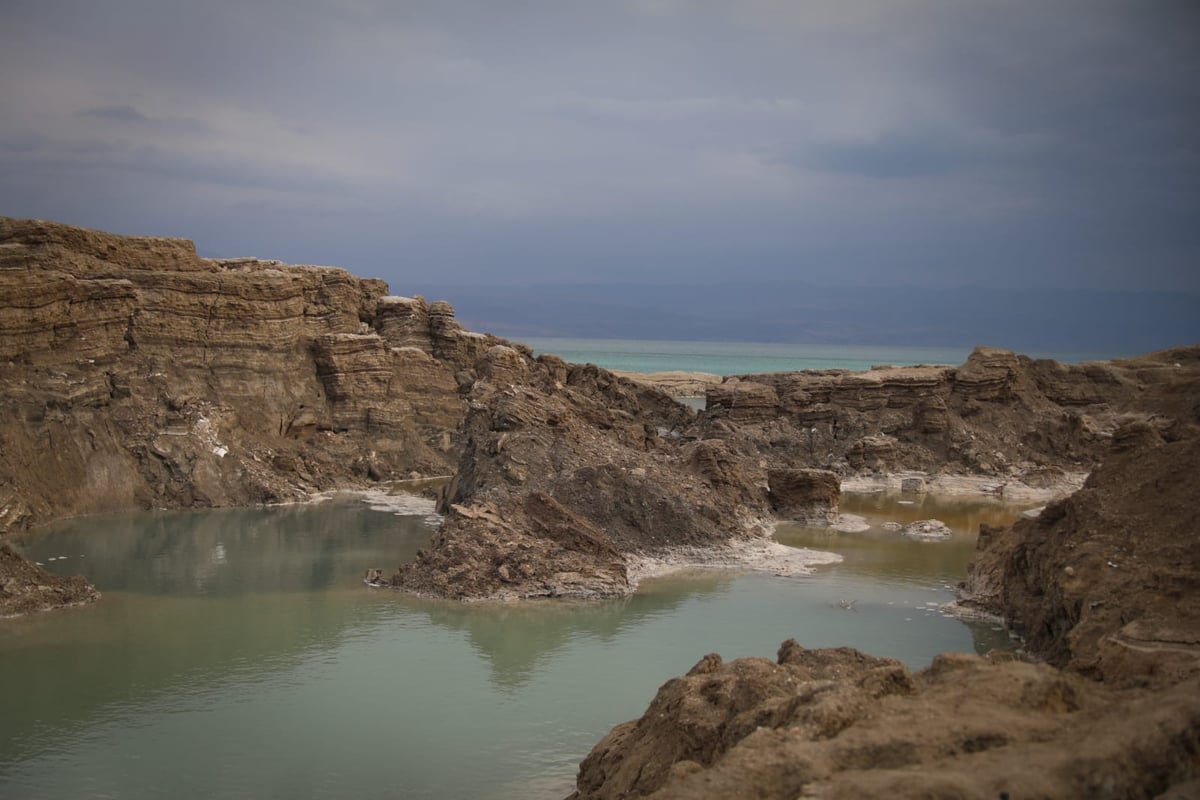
left=391, top=282, right=1200, bottom=354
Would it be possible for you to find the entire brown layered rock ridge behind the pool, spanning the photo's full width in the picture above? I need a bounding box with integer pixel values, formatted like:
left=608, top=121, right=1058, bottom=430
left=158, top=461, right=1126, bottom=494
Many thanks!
left=0, top=218, right=1200, bottom=609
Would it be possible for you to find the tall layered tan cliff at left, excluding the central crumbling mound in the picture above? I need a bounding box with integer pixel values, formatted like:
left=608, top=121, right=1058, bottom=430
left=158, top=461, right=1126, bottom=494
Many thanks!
left=0, top=218, right=488, bottom=533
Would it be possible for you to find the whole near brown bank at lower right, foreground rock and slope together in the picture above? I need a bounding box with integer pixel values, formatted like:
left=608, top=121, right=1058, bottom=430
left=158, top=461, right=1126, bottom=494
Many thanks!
left=572, top=431, right=1200, bottom=800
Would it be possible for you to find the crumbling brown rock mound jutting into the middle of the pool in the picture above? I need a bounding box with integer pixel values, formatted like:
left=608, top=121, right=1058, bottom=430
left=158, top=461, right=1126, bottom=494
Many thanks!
left=392, top=359, right=766, bottom=599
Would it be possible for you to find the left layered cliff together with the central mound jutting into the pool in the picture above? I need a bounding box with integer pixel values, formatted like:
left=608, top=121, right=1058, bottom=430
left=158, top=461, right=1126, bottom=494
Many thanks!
left=0, top=219, right=835, bottom=606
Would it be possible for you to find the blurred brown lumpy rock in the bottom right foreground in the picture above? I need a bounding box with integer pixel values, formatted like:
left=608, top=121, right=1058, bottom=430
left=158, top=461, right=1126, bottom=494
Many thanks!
left=571, top=642, right=1200, bottom=800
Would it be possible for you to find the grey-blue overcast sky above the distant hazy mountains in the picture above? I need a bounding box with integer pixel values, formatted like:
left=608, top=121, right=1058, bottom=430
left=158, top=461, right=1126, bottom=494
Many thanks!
left=0, top=0, right=1200, bottom=293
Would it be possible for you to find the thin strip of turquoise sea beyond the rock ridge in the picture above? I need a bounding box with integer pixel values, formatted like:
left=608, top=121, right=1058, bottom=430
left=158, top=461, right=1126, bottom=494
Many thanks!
left=522, top=338, right=1116, bottom=375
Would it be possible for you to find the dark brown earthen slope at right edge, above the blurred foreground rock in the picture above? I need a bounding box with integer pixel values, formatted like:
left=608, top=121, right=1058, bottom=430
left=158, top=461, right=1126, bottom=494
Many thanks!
left=964, top=424, right=1200, bottom=685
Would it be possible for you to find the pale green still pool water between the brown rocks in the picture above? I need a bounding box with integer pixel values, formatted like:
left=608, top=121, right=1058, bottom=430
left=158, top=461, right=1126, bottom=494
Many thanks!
left=0, top=498, right=1027, bottom=800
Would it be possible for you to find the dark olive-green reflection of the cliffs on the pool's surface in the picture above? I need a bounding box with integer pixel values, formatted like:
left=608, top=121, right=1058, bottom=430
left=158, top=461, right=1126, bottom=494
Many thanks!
left=0, top=504, right=732, bottom=776
